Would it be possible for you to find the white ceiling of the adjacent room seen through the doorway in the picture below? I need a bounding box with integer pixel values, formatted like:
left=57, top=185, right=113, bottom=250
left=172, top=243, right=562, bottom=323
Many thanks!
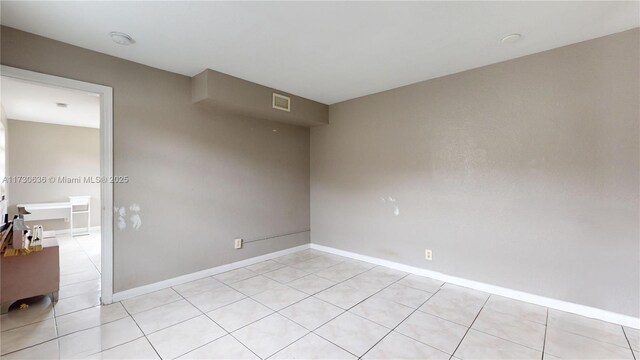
left=0, top=77, right=100, bottom=128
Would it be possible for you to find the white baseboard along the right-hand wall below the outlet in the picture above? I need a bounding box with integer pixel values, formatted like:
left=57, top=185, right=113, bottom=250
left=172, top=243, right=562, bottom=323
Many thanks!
left=310, top=243, right=640, bottom=329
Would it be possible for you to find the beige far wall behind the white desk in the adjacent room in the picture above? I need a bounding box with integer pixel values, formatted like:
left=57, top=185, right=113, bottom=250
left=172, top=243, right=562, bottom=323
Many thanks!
left=7, top=120, right=100, bottom=231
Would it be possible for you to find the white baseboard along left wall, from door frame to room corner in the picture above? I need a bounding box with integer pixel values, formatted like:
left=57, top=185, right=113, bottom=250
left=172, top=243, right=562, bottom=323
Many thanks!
left=112, top=244, right=309, bottom=302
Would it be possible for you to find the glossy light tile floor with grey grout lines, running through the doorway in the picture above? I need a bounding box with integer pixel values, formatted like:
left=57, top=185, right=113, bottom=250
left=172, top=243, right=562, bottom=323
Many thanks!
left=0, top=246, right=640, bottom=360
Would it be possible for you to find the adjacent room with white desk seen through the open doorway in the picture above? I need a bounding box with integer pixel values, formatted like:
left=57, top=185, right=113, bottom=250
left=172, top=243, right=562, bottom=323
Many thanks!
left=0, top=77, right=101, bottom=315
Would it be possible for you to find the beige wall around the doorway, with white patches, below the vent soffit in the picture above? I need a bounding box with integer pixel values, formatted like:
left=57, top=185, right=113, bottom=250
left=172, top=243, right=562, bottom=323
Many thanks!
left=0, top=27, right=309, bottom=291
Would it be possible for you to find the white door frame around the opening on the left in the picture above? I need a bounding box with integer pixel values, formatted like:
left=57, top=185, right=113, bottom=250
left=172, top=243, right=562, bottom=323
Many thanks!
left=0, top=65, right=113, bottom=304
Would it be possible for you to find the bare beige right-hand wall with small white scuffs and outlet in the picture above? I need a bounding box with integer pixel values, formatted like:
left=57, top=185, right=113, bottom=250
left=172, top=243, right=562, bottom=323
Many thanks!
left=311, top=29, right=640, bottom=317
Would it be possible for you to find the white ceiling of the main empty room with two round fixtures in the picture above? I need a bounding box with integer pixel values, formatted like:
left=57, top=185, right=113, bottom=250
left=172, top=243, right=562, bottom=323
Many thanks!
left=1, top=0, right=640, bottom=104
